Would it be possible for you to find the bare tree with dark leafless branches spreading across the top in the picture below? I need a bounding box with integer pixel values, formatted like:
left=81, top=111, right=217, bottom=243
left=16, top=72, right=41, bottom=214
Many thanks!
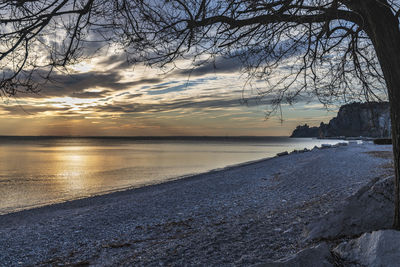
left=0, top=0, right=400, bottom=229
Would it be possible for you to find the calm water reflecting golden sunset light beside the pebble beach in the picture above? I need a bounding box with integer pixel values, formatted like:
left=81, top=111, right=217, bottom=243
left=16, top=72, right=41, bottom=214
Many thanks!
left=0, top=137, right=344, bottom=214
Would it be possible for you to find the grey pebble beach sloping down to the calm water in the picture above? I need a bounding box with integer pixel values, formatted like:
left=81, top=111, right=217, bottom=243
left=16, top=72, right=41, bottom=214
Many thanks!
left=0, top=144, right=391, bottom=266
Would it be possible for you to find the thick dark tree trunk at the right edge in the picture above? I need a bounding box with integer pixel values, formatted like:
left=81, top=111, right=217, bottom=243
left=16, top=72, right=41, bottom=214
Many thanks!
left=356, top=0, right=400, bottom=229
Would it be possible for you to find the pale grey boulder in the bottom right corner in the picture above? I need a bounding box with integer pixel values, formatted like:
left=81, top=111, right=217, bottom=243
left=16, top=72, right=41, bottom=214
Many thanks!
left=334, top=230, right=400, bottom=267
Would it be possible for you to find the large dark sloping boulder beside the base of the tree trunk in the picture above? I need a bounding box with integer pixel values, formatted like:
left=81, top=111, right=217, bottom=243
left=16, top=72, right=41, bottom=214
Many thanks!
left=305, top=177, right=394, bottom=242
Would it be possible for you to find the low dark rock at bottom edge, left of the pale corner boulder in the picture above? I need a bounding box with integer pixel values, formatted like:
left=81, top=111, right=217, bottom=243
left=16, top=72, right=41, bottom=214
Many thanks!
left=258, top=242, right=334, bottom=267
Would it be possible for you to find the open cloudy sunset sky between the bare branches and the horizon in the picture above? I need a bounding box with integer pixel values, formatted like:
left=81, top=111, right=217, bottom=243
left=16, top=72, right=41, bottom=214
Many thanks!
left=0, top=50, right=337, bottom=136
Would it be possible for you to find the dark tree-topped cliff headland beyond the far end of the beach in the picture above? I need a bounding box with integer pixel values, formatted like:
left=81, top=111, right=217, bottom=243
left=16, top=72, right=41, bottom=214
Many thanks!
left=291, top=102, right=391, bottom=138
